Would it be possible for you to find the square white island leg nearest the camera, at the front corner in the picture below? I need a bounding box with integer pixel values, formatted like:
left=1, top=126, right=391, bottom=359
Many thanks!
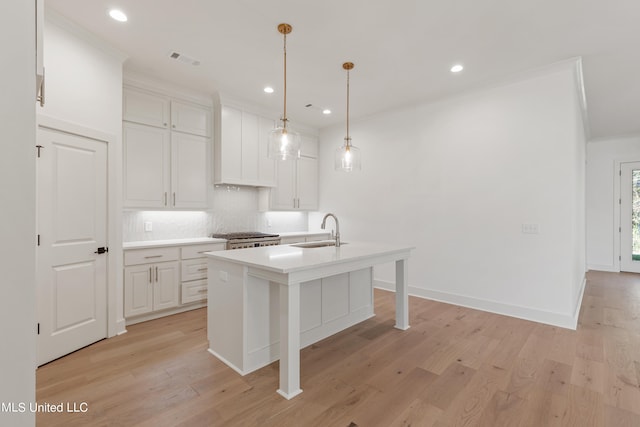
left=278, top=283, right=302, bottom=399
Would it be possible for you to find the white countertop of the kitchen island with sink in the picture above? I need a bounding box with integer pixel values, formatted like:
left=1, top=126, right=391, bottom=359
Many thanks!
left=205, top=242, right=414, bottom=273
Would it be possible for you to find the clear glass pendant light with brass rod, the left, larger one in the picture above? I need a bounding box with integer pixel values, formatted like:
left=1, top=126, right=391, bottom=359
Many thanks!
left=267, top=24, right=300, bottom=160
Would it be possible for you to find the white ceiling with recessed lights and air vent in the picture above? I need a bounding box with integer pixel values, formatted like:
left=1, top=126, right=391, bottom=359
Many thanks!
left=45, top=0, right=640, bottom=138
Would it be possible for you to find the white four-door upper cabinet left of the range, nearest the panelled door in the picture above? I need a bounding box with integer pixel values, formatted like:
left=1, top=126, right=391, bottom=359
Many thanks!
left=123, top=87, right=211, bottom=209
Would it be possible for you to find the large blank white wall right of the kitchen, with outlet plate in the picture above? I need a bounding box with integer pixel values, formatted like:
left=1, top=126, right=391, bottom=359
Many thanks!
left=309, top=62, right=585, bottom=327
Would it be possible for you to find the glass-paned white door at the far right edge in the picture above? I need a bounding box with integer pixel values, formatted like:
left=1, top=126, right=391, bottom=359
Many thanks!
left=620, top=162, right=640, bottom=273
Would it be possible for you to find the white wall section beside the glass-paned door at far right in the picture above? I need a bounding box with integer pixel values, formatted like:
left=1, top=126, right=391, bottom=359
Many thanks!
left=587, top=136, right=640, bottom=271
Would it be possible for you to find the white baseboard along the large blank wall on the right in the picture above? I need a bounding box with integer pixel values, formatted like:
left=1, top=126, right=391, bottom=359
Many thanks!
left=374, top=279, right=586, bottom=330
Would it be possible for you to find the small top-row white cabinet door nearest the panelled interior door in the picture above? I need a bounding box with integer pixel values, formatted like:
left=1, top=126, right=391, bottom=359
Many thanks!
left=122, top=88, right=169, bottom=128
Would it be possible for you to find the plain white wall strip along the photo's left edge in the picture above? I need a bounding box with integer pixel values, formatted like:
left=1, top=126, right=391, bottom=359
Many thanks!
left=0, top=0, right=36, bottom=427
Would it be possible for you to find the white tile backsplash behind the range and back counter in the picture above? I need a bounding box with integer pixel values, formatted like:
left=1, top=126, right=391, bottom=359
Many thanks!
left=122, top=186, right=308, bottom=242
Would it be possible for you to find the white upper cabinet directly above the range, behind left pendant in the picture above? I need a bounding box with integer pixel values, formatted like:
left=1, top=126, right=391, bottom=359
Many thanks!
left=214, top=105, right=276, bottom=187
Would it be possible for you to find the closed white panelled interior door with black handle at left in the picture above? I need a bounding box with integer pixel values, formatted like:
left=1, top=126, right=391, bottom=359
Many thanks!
left=36, top=128, right=108, bottom=365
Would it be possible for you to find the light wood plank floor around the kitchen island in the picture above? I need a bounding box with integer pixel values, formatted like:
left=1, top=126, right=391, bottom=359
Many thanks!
left=37, top=272, right=640, bottom=427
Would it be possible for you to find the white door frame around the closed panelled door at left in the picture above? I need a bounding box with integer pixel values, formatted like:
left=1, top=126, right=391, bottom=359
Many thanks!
left=36, top=114, right=126, bottom=338
